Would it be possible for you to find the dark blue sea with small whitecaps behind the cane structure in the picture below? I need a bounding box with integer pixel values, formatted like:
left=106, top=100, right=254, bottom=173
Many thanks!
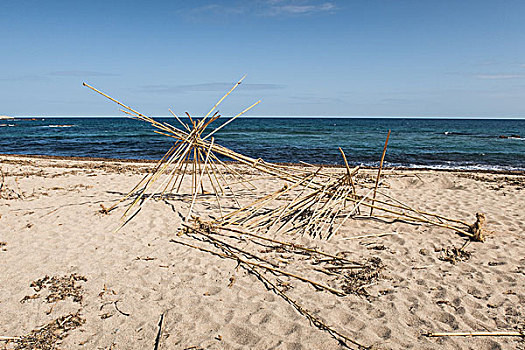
left=0, top=118, right=525, bottom=170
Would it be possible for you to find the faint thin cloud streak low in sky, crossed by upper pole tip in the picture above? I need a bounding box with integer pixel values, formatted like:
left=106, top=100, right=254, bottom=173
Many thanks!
left=140, top=83, right=286, bottom=94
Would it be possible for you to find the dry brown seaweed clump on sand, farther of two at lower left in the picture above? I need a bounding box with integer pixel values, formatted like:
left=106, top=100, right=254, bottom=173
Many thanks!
left=20, top=273, right=87, bottom=303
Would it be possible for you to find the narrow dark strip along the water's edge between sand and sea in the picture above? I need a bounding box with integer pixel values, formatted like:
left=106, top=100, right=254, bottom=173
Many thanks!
left=0, top=153, right=525, bottom=175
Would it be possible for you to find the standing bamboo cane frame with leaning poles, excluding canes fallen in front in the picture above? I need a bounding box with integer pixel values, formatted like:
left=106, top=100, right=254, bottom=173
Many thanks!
left=83, top=76, right=483, bottom=241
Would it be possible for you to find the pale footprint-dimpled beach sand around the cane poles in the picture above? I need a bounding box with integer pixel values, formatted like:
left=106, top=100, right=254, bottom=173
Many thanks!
left=0, top=156, right=525, bottom=349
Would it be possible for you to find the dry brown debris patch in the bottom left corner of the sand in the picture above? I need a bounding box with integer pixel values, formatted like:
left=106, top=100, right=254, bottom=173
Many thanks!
left=2, top=310, right=86, bottom=350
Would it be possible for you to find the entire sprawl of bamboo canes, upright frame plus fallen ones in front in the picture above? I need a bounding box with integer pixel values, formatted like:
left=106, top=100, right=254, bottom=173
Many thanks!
left=83, top=77, right=496, bottom=349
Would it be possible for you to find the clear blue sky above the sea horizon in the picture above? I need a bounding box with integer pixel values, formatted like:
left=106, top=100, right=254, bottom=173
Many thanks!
left=0, top=0, right=525, bottom=118
